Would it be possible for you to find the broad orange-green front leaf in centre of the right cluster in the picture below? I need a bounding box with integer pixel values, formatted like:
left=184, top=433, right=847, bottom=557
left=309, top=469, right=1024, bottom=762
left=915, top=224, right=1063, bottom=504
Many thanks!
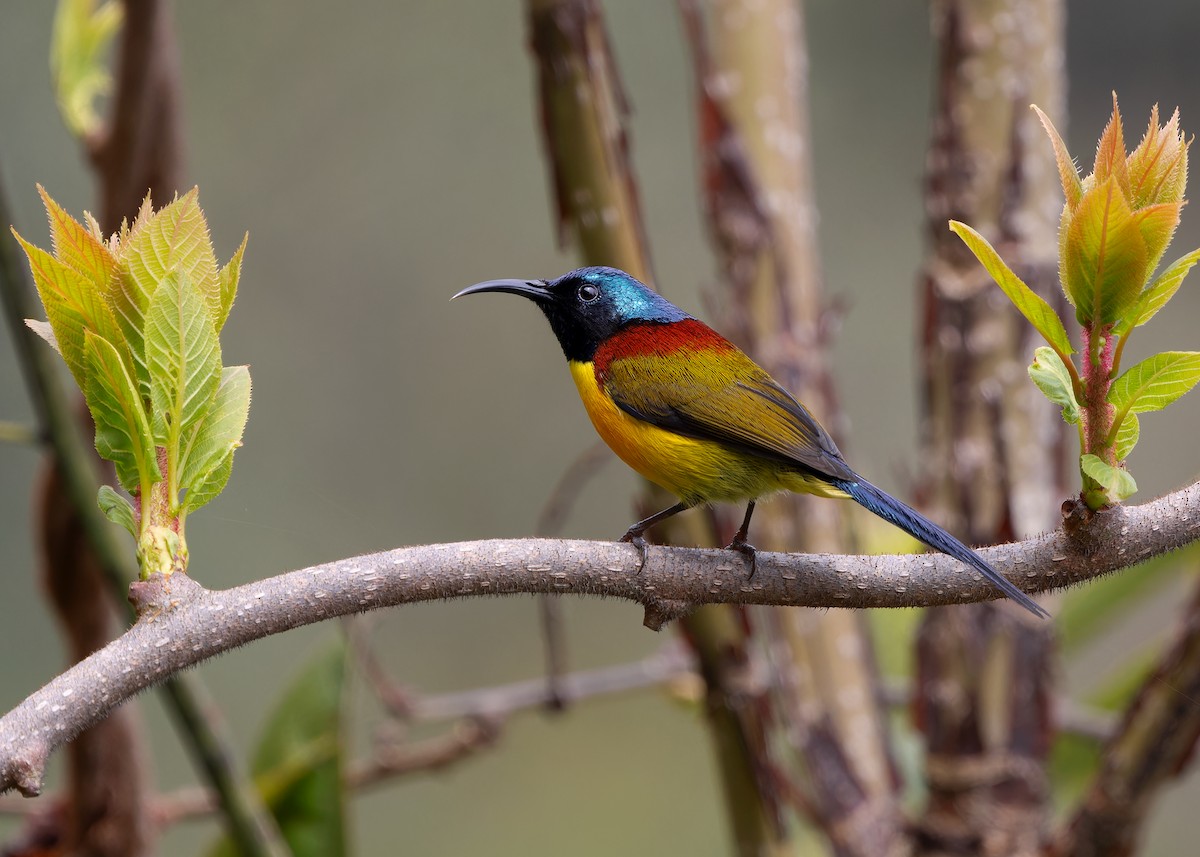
left=1061, top=178, right=1150, bottom=326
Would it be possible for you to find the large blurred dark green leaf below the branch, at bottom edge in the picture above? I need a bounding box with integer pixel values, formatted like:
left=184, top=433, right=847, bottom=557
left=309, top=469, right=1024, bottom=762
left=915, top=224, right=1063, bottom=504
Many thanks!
left=209, top=639, right=347, bottom=857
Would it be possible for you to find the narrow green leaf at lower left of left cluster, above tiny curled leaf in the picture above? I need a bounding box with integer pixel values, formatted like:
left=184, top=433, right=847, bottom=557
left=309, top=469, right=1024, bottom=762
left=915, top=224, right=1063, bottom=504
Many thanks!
left=84, top=331, right=160, bottom=493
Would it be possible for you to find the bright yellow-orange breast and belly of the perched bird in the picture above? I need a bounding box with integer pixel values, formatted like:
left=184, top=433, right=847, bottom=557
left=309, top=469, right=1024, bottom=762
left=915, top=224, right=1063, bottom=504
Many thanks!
left=570, top=361, right=846, bottom=504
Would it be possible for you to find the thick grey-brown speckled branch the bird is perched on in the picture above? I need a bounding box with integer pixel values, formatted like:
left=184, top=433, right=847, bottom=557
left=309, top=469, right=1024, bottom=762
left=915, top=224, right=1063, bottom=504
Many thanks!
left=0, top=484, right=1200, bottom=795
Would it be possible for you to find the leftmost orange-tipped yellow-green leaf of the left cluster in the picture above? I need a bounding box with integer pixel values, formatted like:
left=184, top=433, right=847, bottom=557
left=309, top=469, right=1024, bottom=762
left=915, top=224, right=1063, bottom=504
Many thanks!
left=13, top=229, right=121, bottom=390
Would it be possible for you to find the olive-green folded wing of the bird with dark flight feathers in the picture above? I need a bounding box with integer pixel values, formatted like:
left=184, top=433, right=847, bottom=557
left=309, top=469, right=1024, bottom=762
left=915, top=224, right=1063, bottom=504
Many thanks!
left=601, top=350, right=857, bottom=480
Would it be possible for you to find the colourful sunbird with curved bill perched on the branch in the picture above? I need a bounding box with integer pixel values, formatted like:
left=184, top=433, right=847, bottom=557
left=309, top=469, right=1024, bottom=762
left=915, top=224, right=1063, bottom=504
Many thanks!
left=451, top=260, right=1049, bottom=618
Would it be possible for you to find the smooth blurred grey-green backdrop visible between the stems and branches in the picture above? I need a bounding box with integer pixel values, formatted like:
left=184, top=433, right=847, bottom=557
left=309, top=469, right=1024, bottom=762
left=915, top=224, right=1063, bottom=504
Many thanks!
left=0, top=0, right=1200, bottom=855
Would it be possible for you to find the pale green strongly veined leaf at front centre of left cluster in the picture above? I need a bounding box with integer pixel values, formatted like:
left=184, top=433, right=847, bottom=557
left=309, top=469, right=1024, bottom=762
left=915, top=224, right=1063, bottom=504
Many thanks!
left=145, top=271, right=221, bottom=446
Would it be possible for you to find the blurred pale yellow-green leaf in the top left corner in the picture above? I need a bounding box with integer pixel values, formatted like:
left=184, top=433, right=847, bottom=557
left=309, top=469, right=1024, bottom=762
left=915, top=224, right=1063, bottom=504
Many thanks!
left=50, top=0, right=124, bottom=137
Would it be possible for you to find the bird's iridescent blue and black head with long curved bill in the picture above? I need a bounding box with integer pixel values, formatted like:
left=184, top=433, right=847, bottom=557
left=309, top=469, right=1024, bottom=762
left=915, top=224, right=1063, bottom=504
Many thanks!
left=451, top=268, right=690, bottom=362
